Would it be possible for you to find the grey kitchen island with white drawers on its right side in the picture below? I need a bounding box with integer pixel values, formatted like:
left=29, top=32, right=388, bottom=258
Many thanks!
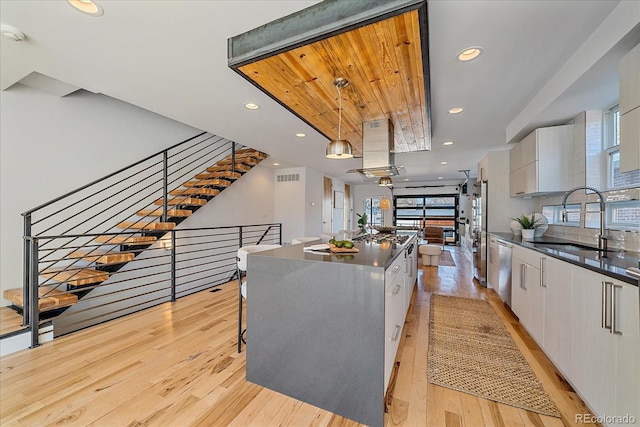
left=242, top=233, right=417, bottom=426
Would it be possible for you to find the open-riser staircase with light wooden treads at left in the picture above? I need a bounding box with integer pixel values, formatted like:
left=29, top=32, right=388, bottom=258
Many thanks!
left=3, top=142, right=267, bottom=320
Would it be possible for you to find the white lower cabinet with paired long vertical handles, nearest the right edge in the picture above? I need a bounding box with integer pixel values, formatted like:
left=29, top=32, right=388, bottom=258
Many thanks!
left=571, top=266, right=640, bottom=419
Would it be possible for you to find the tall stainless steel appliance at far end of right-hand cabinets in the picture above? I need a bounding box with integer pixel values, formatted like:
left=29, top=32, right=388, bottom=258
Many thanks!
left=471, top=181, right=489, bottom=288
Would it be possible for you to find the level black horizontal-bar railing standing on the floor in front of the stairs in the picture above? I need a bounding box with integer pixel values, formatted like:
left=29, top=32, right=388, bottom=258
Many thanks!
left=27, top=223, right=282, bottom=347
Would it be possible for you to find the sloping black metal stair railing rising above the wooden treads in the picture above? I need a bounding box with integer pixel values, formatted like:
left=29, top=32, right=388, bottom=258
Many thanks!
left=16, top=132, right=264, bottom=342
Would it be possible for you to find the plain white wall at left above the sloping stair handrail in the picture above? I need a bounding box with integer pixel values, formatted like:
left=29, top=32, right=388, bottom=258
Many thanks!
left=0, top=85, right=200, bottom=304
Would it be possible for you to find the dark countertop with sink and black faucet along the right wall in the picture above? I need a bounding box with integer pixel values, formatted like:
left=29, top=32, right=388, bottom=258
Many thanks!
left=489, top=232, right=640, bottom=286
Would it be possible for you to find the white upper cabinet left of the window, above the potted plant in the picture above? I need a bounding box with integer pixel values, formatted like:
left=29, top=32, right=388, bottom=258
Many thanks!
left=509, top=125, right=574, bottom=197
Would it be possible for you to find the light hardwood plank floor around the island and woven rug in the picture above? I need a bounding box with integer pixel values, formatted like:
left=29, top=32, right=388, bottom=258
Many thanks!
left=0, top=247, right=600, bottom=427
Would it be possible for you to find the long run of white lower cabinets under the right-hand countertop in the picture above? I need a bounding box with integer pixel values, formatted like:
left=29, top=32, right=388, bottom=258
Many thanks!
left=511, top=245, right=640, bottom=425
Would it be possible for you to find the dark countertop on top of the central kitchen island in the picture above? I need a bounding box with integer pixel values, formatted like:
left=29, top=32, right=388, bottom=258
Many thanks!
left=250, top=231, right=417, bottom=269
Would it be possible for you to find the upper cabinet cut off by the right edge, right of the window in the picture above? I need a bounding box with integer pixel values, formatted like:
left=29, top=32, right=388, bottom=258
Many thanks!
left=619, top=44, right=640, bottom=172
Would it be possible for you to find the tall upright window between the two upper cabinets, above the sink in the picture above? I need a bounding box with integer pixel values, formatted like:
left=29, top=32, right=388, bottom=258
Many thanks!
left=604, top=105, right=640, bottom=190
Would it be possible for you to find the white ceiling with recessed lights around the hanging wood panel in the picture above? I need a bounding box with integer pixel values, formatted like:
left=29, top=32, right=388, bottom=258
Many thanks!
left=0, top=0, right=640, bottom=183
